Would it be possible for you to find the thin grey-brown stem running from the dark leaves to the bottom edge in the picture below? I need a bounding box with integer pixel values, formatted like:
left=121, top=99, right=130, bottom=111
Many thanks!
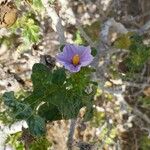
left=67, top=119, right=77, bottom=150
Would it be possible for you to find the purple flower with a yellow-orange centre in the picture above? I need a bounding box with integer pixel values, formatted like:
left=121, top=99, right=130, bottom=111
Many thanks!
left=56, top=44, right=93, bottom=72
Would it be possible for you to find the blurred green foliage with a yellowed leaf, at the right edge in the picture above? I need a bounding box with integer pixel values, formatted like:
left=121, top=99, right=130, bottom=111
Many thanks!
left=114, top=33, right=150, bottom=74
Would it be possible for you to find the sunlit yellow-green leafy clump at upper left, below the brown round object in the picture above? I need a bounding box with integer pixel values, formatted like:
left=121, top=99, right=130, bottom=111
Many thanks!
left=0, top=15, right=40, bottom=51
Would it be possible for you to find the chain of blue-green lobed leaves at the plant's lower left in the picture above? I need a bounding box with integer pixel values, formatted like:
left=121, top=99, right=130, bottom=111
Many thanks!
left=3, top=92, right=45, bottom=136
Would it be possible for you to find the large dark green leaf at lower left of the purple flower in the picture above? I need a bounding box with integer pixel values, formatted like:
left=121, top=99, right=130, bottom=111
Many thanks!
left=24, top=63, right=53, bottom=109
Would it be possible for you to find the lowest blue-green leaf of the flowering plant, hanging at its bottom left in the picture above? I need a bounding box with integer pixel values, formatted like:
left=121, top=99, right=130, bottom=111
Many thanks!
left=27, top=115, right=46, bottom=136
